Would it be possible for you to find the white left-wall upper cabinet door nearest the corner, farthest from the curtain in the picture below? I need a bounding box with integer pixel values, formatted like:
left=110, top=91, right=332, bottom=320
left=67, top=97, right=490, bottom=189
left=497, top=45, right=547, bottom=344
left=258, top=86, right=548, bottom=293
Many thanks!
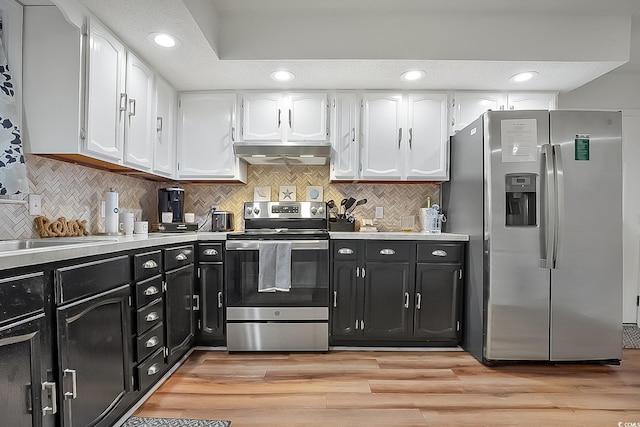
left=153, top=77, right=178, bottom=178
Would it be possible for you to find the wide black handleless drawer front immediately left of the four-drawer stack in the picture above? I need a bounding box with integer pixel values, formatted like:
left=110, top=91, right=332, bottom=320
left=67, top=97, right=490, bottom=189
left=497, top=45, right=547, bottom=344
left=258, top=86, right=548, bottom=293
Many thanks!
left=55, top=255, right=131, bottom=304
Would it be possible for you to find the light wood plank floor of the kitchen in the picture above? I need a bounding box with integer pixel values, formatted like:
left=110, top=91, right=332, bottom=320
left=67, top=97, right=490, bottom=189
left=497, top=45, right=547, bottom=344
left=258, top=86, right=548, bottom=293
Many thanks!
left=135, top=350, right=640, bottom=427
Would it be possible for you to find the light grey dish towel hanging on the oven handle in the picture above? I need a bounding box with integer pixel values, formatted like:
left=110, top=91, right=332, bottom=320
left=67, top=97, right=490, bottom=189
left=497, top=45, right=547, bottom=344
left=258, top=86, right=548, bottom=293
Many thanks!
left=258, top=242, right=291, bottom=292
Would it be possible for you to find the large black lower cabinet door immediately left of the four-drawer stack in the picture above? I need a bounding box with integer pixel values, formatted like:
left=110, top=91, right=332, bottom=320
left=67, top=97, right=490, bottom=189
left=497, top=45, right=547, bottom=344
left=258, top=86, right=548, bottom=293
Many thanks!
left=57, top=284, right=132, bottom=427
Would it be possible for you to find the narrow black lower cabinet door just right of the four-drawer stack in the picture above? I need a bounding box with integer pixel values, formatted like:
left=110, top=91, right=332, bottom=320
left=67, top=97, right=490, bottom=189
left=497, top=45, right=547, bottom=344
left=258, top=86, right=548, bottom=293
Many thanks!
left=165, top=264, right=195, bottom=365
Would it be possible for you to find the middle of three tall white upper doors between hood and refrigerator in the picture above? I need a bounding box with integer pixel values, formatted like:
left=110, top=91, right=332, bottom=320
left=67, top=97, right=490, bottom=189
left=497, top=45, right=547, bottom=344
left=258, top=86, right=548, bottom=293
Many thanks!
left=360, top=93, right=406, bottom=180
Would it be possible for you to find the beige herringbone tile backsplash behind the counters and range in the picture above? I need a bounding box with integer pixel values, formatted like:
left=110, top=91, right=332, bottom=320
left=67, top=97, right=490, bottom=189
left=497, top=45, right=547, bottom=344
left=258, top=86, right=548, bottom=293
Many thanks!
left=0, top=155, right=440, bottom=240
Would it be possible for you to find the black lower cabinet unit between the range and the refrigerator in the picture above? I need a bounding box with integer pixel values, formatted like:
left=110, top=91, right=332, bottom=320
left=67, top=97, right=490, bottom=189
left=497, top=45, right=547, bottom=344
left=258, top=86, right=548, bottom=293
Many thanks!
left=330, top=240, right=464, bottom=346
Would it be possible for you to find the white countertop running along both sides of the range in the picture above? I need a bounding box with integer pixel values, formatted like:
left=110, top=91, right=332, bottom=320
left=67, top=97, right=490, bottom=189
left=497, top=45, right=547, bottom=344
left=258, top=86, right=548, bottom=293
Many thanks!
left=0, top=231, right=469, bottom=270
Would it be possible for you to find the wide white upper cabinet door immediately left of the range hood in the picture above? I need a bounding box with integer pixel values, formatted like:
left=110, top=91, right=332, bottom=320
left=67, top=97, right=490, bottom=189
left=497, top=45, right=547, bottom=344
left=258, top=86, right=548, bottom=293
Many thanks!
left=177, top=92, right=247, bottom=182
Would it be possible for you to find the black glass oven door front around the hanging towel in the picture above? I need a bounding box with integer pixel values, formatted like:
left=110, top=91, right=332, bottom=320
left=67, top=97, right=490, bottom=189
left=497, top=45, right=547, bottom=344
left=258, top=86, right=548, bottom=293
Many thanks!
left=225, top=244, right=329, bottom=307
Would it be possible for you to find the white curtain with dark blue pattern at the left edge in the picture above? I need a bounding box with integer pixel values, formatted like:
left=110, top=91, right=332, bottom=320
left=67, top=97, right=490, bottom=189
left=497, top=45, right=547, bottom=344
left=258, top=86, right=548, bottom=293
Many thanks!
left=0, top=33, right=29, bottom=197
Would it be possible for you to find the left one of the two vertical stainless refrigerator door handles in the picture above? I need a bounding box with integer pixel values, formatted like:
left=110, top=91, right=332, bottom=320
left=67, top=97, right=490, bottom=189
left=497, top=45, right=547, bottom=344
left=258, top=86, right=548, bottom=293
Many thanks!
left=540, top=144, right=556, bottom=269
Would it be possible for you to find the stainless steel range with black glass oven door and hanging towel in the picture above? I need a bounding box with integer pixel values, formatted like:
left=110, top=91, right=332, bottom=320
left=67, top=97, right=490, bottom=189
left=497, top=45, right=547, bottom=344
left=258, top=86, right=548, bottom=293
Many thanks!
left=225, top=202, right=329, bottom=351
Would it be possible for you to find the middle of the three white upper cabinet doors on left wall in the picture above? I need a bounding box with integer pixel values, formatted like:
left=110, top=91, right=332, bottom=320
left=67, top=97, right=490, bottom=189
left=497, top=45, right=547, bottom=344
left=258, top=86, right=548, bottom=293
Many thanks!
left=124, top=52, right=156, bottom=171
